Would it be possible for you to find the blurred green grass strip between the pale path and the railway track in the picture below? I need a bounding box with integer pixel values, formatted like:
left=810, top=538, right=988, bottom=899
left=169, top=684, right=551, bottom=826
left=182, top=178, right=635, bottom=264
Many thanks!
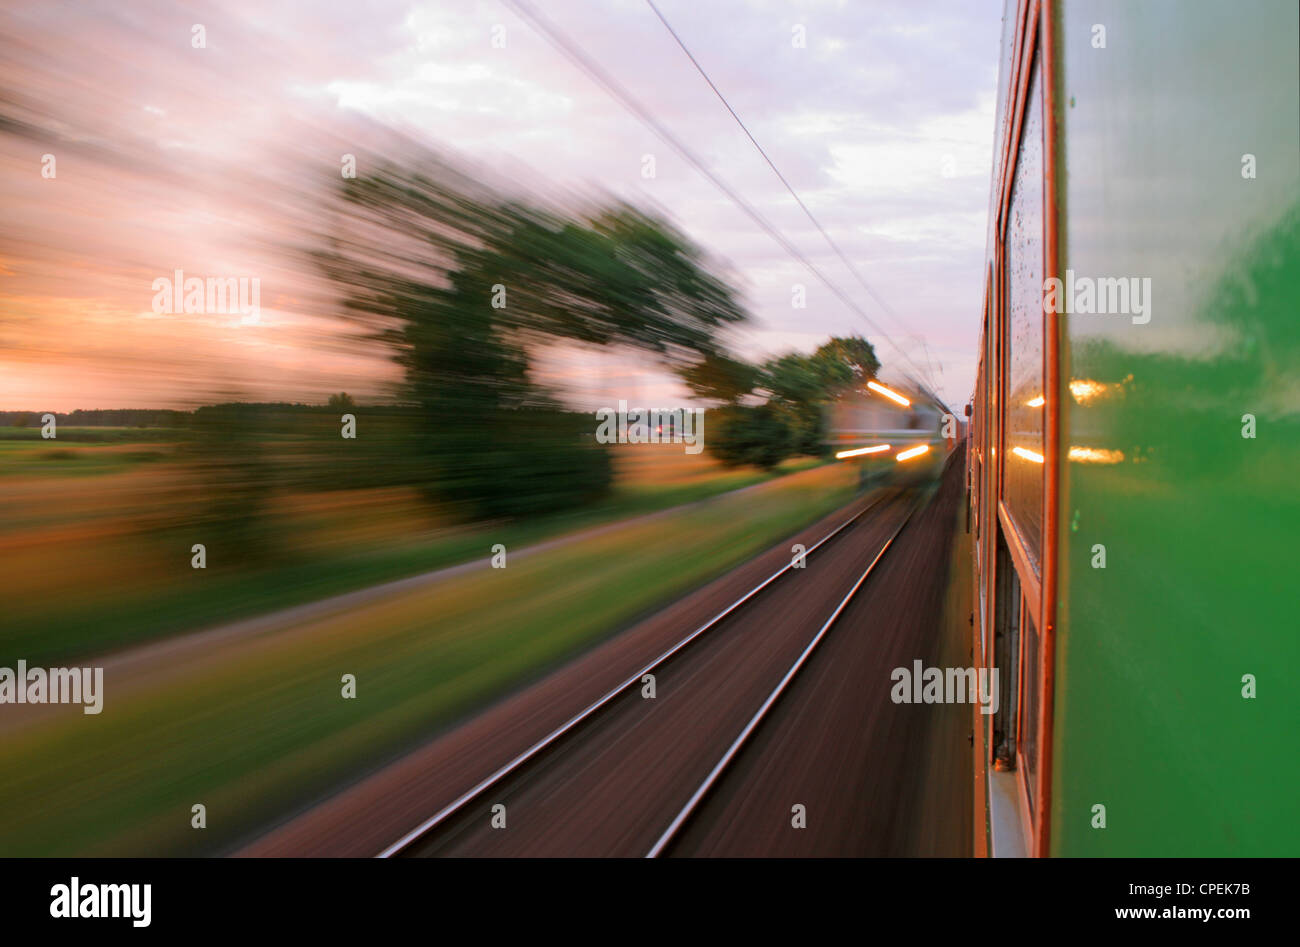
left=0, top=464, right=855, bottom=856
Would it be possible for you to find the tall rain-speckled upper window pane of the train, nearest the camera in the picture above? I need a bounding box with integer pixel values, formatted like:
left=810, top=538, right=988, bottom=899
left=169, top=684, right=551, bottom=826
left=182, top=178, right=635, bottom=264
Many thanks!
left=1002, top=56, right=1047, bottom=572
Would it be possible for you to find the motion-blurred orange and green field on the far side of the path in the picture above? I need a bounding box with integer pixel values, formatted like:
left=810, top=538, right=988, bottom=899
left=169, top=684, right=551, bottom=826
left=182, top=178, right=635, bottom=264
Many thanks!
left=0, top=428, right=815, bottom=665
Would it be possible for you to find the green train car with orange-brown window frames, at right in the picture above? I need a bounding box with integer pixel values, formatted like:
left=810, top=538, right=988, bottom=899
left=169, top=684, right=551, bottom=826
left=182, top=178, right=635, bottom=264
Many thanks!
left=967, top=0, right=1300, bottom=856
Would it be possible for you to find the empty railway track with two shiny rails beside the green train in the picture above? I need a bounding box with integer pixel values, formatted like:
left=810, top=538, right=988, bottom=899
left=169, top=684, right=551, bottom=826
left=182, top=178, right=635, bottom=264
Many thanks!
left=378, top=493, right=915, bottom=857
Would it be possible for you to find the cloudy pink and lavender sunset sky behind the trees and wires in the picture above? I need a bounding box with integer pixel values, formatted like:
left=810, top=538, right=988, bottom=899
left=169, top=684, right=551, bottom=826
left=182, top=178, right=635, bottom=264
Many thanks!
left=0, top=0, right=1001, bottom=411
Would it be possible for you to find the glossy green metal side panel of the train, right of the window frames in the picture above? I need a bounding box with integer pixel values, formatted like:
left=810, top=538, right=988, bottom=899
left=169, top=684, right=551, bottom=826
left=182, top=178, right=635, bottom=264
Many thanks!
left=1050, top=0, right=1300, bottom=855
